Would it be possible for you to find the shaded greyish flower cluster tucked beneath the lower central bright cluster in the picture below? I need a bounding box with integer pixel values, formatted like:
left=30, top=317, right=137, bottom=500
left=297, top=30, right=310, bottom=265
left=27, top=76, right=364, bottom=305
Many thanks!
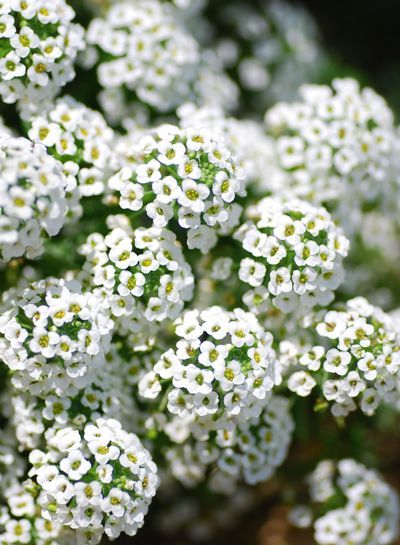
left=166, top=396, right=293, bottom=494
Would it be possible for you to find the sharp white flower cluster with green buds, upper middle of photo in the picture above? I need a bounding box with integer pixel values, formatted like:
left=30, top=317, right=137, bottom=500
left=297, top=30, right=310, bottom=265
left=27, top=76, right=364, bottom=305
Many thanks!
left=109, top=125, right=245, bottom=253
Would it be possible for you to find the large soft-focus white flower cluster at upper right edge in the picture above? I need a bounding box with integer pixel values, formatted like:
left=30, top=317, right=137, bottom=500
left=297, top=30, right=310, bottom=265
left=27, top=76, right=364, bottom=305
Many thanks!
left=265, top=79, right=398, bottom=232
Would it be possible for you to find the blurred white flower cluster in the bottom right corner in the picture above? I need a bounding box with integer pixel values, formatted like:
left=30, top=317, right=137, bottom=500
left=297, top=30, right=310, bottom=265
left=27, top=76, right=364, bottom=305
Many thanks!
left=291, top=459, right=400, bottom=545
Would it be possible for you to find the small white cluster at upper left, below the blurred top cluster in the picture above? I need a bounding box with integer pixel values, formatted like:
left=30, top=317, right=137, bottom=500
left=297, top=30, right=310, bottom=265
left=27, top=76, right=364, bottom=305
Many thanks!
left=28, top=96, right=114, bottom=197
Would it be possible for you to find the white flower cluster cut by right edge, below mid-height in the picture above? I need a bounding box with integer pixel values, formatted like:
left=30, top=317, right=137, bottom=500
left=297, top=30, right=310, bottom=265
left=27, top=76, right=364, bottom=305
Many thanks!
left=288, top=297, right=400, bottom=416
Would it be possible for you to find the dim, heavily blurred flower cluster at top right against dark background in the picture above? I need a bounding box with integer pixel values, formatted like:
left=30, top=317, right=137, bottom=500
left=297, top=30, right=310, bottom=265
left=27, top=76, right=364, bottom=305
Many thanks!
left=216, top=0, right=320, bottom=108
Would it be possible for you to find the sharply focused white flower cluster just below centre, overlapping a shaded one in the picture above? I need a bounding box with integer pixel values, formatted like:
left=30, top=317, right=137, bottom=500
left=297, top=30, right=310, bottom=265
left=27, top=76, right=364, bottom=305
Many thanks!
left=139, top=307, right=280, bottom=431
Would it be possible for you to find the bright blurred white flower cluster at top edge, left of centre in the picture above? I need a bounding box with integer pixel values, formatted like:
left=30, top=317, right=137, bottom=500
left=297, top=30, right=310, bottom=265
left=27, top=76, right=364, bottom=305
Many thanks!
left=87, top=0, right=236, bottom=120
